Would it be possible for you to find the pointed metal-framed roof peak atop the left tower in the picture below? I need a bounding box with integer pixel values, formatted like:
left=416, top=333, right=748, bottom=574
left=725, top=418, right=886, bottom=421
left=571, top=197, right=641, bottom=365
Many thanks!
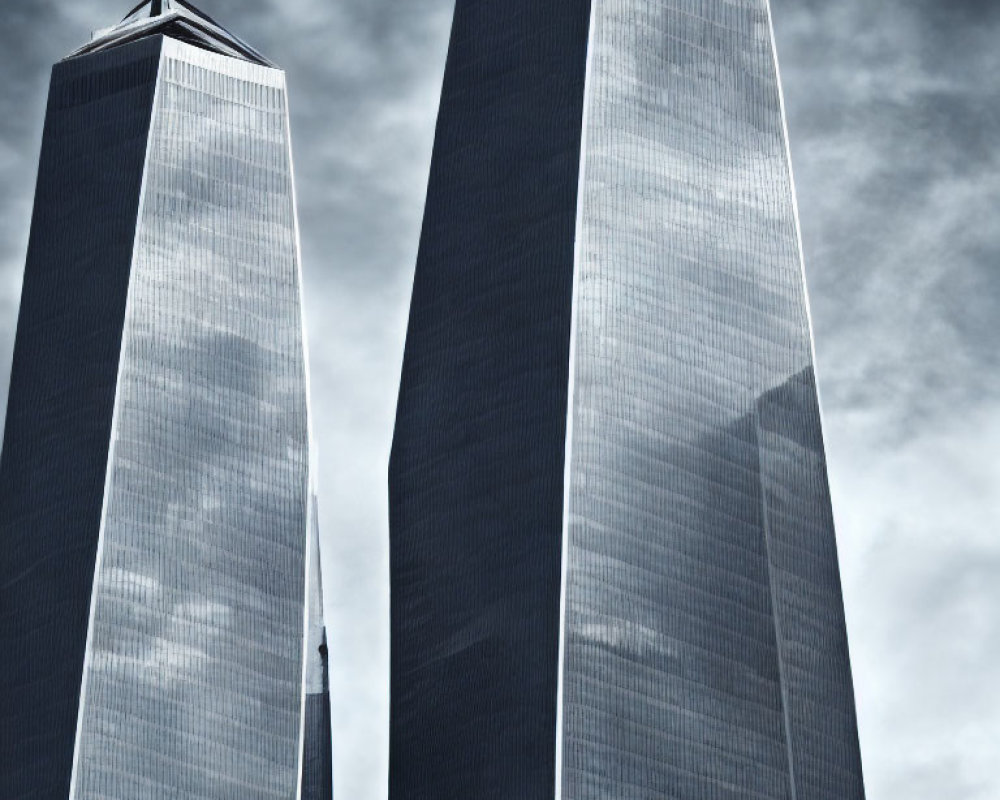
left=67, top=0, right=274, bottom=67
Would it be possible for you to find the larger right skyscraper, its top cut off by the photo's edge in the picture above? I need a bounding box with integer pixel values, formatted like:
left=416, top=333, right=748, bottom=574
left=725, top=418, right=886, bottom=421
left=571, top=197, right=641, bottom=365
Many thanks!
left=389, top=0, right=864, bottom=800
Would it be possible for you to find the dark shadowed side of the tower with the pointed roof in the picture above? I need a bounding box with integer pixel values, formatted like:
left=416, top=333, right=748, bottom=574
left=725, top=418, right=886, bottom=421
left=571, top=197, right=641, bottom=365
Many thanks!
left=0, top=40, right=160, bottom=800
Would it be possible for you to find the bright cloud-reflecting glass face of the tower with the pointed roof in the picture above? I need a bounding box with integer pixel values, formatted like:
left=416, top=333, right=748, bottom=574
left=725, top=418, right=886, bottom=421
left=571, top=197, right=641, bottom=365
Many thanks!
left=77, top=40, right=308, bottom=798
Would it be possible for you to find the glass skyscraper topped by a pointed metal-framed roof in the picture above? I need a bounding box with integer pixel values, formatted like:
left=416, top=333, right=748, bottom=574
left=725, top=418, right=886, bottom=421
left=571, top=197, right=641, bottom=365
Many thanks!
left=0, top=0, right=330, bottom=800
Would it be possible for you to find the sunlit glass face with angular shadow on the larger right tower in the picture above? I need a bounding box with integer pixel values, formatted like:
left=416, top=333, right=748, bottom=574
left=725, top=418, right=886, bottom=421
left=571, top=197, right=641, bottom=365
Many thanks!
left=562, top=0, right=863, bottom=800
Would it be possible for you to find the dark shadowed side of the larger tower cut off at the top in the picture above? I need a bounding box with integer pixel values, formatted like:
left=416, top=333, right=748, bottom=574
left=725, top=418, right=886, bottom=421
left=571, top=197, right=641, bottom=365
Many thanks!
left=389, top=0, right=589, bottom=800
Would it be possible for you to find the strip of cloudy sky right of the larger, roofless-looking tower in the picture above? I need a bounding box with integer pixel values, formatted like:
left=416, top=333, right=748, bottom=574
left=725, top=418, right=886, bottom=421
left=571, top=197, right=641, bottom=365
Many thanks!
left=774, top=10, right=1000, bottom=800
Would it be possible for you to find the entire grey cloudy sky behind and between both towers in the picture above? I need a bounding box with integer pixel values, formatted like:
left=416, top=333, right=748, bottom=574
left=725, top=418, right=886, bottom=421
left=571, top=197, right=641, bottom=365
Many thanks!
left=0, top=0, right=1000, bottom=800
